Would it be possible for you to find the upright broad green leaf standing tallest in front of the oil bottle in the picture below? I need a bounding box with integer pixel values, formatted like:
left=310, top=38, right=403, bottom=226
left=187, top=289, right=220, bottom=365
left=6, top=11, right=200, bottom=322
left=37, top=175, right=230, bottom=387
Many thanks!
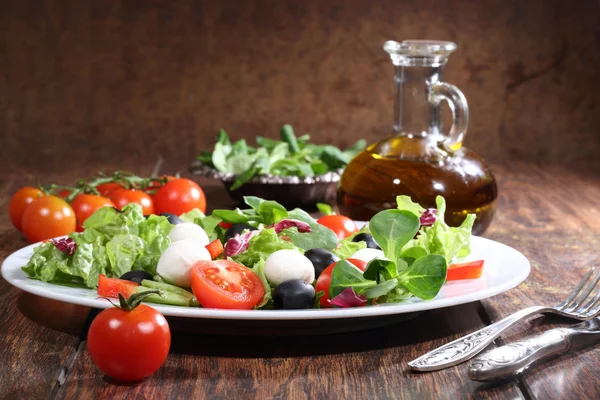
left=369, top=210, right=421, bottom=261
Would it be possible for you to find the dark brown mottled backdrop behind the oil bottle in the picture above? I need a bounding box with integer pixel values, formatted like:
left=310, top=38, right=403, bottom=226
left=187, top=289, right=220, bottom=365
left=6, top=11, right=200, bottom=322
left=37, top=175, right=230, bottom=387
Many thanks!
left=0, top=0, right=600, bottom=177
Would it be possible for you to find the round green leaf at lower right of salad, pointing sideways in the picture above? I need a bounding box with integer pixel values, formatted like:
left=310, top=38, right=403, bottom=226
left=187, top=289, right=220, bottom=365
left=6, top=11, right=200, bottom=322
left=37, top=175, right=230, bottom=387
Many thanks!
left=398, top=254, right=446, bottom=300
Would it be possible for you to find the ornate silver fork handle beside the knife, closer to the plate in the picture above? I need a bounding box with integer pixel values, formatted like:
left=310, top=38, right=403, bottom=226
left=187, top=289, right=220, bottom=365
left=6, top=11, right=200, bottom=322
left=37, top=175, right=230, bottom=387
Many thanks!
left=408, top=306, right=551, bottom=371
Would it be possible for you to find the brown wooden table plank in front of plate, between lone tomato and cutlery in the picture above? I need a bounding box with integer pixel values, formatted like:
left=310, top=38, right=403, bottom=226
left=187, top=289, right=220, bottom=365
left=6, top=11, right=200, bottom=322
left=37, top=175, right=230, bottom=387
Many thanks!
left=58, top=303, right=521, bottom=399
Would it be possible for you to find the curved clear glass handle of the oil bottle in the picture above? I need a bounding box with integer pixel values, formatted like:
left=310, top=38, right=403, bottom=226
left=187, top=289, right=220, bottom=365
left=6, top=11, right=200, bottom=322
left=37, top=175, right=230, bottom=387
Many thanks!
left=429, top=82, right=469, bottom=153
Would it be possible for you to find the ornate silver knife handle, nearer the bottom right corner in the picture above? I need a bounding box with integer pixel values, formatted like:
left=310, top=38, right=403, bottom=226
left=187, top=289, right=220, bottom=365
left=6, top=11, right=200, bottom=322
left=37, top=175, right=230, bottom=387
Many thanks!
left=469, top=328, right=571, bottom=382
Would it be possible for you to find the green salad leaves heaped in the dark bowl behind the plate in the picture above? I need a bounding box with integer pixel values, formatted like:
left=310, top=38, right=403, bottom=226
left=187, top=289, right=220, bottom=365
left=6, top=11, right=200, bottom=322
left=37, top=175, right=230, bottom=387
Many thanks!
left=198, top=125, right=366, bottom=190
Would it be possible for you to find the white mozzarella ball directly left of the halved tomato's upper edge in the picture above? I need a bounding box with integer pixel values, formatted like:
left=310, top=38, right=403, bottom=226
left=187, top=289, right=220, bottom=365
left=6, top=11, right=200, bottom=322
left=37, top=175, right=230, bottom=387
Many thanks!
left=156, top=240, right=211, bottom=288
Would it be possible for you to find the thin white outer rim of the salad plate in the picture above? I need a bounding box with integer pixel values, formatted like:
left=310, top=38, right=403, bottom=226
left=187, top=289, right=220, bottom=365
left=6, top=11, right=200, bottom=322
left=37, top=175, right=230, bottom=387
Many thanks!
left=2, top=236, right=531, bottom=321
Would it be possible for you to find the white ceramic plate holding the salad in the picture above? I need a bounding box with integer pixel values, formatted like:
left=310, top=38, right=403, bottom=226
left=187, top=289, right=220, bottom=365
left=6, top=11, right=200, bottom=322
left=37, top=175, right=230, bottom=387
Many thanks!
left=2, top=237, right=530, bottom=321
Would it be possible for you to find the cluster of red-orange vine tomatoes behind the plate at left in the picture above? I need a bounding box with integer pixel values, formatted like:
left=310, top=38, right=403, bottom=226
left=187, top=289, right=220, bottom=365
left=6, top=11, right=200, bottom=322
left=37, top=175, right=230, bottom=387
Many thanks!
left=9, top=172, right=206, bottom=243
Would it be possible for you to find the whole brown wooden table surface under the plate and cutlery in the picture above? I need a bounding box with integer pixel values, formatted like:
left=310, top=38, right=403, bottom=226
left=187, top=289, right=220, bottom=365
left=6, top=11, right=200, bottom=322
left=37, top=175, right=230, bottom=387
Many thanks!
left=0, top=163, right=600, bottom=399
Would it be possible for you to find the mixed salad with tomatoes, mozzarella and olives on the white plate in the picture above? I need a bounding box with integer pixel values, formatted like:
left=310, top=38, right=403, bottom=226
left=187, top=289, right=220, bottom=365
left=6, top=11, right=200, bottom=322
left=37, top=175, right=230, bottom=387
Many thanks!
left=23, top=196, right=475, bottom=309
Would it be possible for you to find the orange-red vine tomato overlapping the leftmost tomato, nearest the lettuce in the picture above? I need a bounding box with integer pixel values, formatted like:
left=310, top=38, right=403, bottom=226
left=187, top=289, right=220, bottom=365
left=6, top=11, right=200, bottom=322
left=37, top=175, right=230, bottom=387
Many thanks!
left=21, top=196, right=75, bottom=243
